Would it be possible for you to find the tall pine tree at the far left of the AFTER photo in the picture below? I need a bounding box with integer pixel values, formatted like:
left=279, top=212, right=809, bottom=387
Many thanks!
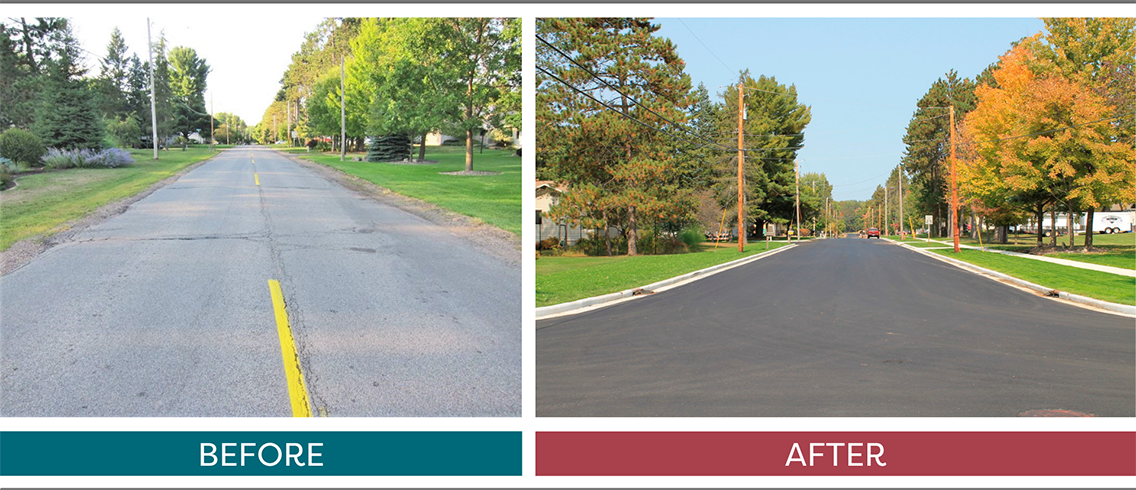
left=537, top=18, right=695, bottom=255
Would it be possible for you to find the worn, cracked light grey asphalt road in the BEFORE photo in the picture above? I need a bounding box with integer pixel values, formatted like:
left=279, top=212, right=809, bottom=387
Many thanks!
left=0, top=148, right=520, bottom=416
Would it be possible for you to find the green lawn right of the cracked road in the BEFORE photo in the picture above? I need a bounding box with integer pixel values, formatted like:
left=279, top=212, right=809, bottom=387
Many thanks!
left=294, top=147, right=521, bottom=236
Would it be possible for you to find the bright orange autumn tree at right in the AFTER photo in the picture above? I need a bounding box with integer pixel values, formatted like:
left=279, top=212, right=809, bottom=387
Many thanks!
left=960, top=35, right=1134, bottom=248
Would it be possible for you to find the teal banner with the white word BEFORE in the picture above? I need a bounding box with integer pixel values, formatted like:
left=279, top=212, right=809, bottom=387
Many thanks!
left=0, top=432, right=521, bottom=476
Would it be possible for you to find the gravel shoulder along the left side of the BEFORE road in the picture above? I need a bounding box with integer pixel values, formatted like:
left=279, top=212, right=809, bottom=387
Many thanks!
left=0, top=152, right=222, bottom=276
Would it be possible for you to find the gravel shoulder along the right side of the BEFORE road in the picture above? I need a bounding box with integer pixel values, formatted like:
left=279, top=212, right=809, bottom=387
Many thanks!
left=277, top=148, right=521, bottom=267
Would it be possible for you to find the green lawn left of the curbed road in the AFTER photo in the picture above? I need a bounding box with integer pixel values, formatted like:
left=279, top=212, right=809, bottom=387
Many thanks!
left=536, top=241, right=788, bottom=307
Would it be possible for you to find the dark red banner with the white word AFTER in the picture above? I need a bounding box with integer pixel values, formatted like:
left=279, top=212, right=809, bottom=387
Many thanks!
left=536, top=432, right=1136, bottom=476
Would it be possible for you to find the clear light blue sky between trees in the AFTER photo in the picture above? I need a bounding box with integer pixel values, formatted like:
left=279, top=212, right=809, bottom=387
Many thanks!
left=655, top=17, right=1043, bottom=200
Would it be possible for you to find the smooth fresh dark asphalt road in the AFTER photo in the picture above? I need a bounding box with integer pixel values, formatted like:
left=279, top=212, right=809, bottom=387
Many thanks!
left=536, top=239, right=1136, bottom=417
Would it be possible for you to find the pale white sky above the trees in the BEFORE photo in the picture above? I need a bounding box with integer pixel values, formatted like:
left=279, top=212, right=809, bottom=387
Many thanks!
left=68, top=13, right=323, bottom=125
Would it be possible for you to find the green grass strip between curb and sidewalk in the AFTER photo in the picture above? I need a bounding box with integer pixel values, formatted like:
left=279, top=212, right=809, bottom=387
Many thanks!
left=932, top=250, right=1136, bottom=305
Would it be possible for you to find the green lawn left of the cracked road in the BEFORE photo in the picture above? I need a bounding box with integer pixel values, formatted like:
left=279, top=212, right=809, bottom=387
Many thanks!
left=0, top=147, right=215, bottom=251
